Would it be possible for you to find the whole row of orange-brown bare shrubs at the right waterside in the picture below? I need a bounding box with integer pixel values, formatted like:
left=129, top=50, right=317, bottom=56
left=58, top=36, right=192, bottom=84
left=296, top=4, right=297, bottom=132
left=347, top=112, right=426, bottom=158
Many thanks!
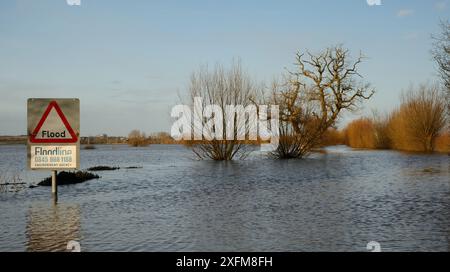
left=345, top=84, right=450, bottom=152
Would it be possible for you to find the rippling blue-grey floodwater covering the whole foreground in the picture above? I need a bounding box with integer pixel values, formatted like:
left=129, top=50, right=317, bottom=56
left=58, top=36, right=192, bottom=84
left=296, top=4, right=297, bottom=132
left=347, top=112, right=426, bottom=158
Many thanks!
left=0, top=145, right=450, bottom=251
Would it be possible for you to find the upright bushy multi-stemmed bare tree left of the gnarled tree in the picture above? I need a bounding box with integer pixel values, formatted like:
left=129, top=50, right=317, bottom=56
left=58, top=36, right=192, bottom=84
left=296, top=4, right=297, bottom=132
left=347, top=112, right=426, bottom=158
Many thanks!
left=188, top=62, right=257, bottom=160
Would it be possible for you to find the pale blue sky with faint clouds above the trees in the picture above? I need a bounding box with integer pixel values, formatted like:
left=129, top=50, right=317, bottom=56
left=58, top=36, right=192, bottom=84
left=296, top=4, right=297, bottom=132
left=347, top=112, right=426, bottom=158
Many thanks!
left=0, top=0, right=450, bottom=135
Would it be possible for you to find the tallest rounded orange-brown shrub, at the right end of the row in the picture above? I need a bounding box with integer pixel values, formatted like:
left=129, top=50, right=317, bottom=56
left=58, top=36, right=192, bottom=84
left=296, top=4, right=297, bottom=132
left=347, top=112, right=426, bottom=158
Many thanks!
left=388, top=85, right=447, bottom=152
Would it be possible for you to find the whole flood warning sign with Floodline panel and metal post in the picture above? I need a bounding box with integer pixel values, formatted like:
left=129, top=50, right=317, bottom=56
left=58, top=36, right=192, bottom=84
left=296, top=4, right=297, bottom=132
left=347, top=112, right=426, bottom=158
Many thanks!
left=27, top=98, right=80, bottom=201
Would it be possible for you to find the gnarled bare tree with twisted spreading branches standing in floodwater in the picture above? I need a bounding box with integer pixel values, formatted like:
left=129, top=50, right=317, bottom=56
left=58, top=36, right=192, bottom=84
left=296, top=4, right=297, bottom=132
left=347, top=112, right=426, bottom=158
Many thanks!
left=272, top=46, right=374, bottom=158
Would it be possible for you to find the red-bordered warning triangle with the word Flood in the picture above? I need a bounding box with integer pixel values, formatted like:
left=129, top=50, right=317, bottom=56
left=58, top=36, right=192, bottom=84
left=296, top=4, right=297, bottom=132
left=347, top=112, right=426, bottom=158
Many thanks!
left=30, top=101, right=78, bottom=143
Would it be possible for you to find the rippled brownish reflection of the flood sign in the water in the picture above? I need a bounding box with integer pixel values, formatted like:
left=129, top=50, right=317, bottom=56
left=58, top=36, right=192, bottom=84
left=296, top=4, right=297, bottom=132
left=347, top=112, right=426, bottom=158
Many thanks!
left=26, top=203, right=81, bottom=251
